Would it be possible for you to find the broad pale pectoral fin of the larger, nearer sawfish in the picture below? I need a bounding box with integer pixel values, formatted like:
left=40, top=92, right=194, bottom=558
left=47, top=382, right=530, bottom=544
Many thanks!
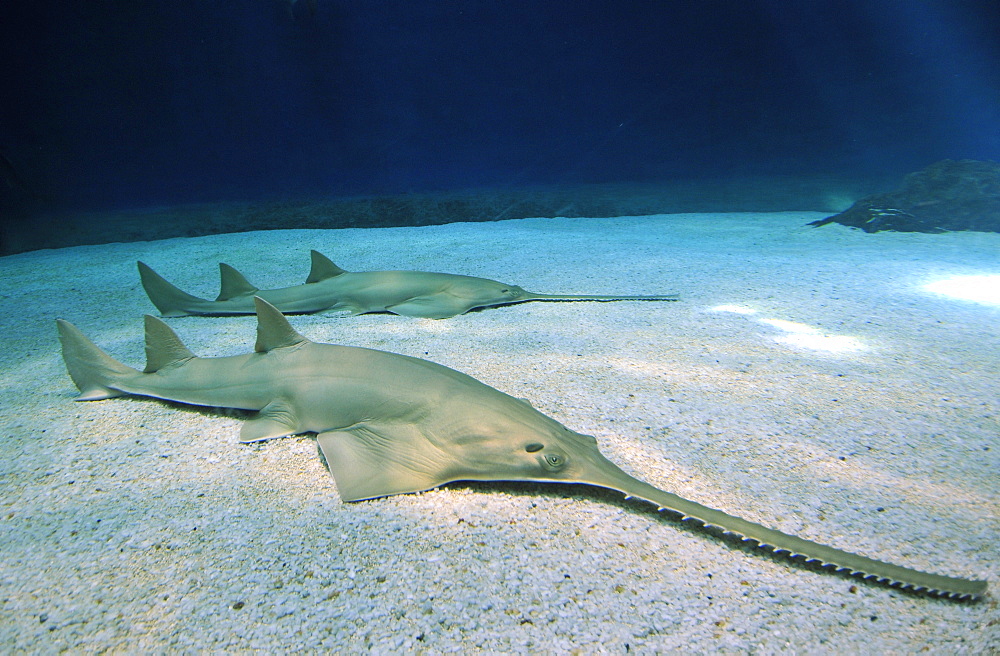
left=316, top=426, right=449, bottom=501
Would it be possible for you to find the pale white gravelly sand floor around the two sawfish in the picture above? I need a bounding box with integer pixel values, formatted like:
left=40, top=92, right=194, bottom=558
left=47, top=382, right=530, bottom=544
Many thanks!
left=0, top=212, right=1000, bottom=654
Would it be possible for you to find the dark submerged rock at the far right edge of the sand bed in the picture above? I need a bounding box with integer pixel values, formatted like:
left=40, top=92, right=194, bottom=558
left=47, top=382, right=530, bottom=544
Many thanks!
left=809, top=159, right=1000, bottom=232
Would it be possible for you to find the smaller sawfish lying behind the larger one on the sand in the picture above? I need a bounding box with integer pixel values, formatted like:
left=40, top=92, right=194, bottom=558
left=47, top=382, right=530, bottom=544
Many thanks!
left=138, top=251, right=677, bottom=319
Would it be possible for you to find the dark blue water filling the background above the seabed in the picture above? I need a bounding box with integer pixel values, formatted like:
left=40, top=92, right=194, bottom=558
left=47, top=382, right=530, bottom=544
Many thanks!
left=0, top=0, right=1000, bottom=238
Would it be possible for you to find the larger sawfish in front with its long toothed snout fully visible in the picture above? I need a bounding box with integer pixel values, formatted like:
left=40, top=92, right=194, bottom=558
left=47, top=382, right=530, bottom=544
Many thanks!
left=57, top=297, right=987, bottom=600
